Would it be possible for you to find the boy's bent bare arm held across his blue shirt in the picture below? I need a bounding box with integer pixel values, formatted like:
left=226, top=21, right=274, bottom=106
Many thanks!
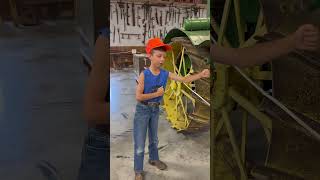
left=136, top=73, right=164, bottom=101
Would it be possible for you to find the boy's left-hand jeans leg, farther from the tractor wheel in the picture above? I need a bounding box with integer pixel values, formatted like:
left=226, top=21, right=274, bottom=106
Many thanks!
left=133, top=103, right=150, bottom=173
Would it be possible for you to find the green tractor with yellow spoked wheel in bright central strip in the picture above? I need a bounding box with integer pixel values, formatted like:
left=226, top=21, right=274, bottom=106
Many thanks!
left=164, top=18, right=210, bottom=131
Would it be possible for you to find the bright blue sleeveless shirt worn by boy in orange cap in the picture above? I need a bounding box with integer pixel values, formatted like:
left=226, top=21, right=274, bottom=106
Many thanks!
left=143, top=69, right=169, bottom=102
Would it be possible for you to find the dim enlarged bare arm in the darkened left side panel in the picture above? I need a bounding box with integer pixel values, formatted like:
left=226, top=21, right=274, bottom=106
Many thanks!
left=84, top=36, right=109, bottom=124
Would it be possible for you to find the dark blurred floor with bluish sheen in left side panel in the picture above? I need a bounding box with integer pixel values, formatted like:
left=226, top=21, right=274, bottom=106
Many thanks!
left=0, top=21, right=86, bottom=180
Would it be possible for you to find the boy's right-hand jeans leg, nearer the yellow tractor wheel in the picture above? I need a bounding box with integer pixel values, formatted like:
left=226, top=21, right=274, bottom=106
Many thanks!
left=148, top=107, right=159, bottom=160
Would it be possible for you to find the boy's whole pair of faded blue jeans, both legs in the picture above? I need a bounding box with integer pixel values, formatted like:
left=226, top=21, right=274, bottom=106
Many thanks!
left=133, top=102, right=159, bottom=173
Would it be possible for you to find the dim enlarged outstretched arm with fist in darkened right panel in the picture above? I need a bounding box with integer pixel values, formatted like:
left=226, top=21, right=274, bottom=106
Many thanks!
left=210, top=25, right=319, bottom=67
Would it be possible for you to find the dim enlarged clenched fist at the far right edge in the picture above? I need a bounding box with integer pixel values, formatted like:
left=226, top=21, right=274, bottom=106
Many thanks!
left=293, top=24, right=320, bottom=51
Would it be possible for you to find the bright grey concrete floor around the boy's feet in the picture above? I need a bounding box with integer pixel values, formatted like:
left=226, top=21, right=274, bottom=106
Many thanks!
left=110, top=69, right=210, bottom=180
